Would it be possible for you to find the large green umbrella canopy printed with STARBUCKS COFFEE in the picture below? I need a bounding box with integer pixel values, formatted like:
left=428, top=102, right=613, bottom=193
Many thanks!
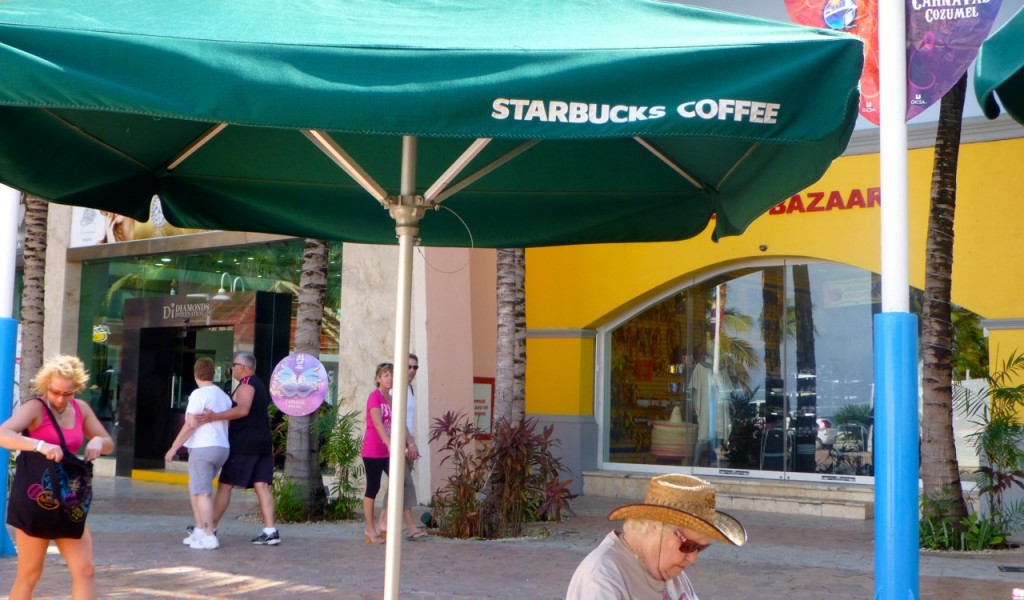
left=0, top=0, right=862, bottom=247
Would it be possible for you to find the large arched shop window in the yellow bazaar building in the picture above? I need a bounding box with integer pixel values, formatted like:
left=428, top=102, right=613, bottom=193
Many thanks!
left=606, top=263, right=880, bottom=476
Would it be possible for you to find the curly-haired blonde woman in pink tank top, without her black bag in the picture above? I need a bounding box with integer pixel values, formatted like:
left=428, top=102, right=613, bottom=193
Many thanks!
left=0, top=355, right=114, bottom=600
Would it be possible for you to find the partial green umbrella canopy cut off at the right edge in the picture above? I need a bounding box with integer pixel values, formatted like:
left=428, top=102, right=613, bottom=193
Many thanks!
left=974, top=9, right=1024, bottom=124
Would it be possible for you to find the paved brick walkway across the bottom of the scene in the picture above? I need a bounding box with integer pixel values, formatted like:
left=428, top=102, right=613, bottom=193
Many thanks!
left=0, top=477, right=1024, bottom=600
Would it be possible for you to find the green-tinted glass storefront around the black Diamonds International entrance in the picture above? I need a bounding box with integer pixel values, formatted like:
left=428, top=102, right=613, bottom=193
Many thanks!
left=78, top=240, right=341, bottom=427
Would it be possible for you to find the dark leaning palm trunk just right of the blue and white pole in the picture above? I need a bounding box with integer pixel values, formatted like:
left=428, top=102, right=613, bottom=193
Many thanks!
left=921, top=75, right=967, bottom=526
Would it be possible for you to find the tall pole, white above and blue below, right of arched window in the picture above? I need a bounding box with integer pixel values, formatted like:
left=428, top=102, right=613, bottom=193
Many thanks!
left=874, top=1, right=920, bottom=600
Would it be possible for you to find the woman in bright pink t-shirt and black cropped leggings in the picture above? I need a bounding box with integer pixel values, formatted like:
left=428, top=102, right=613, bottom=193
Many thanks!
left=361, top=362, right=394, bottom=544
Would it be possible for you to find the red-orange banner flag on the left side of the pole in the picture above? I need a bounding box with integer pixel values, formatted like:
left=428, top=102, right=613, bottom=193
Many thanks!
left=785, top=0, right=879, bottom=125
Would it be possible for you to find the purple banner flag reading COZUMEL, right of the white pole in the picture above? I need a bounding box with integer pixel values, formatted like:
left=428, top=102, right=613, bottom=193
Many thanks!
left=906, top=0, right=1002, bottom=121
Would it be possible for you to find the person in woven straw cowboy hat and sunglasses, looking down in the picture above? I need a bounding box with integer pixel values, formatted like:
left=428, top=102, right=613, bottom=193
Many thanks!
left=565, top=475, right=746, bottom=600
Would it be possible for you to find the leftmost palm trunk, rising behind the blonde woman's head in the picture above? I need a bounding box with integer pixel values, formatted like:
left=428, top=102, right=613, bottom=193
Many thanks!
left=19, top=196, right=50, bottom=402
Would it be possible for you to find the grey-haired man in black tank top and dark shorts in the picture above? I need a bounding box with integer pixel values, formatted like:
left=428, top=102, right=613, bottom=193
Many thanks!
left=198, top=352, right=281, bottom=546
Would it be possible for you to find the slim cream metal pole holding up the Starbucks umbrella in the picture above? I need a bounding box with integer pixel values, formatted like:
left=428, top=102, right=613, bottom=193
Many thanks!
left=384, top=136, right=424, bottom=600
